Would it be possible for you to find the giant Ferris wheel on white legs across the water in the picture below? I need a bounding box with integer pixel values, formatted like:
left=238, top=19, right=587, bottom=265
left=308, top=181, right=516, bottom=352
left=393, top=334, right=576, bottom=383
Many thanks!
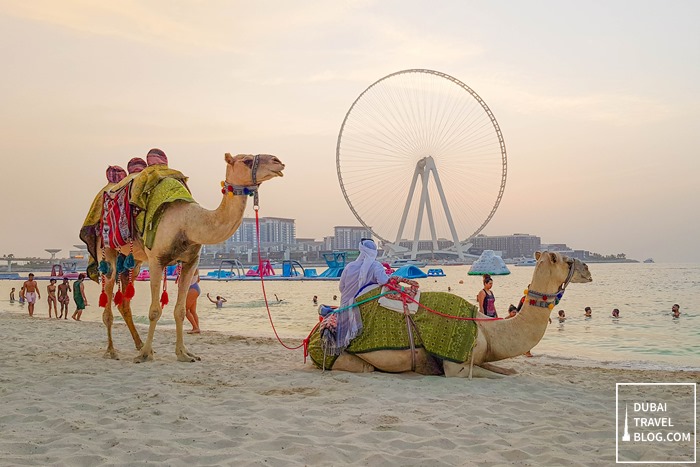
left=336, top=69, right=507, bottom=259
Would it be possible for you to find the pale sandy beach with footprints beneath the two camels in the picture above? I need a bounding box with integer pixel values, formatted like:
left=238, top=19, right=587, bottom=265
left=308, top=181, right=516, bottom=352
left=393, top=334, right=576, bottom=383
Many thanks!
left=0, top=312, right=700, bottom=466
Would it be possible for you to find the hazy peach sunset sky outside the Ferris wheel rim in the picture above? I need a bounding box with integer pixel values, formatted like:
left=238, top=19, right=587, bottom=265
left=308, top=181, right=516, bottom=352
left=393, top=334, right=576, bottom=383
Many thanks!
left=0, top=0, right=700, bottom=262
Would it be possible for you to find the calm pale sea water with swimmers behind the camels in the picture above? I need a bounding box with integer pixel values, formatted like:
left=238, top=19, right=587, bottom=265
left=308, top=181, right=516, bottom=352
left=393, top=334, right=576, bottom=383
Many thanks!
left=0, top=263, right=700, bottom=370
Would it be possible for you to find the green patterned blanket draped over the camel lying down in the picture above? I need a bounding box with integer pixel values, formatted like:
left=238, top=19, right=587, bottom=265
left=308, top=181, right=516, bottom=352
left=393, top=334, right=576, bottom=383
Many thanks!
left=309, top=289, right=477, bottom=369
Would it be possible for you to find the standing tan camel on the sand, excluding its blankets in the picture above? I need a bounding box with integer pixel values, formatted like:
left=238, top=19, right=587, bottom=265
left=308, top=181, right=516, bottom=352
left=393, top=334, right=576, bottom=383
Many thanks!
left=88, top=153, right=284, bottom=363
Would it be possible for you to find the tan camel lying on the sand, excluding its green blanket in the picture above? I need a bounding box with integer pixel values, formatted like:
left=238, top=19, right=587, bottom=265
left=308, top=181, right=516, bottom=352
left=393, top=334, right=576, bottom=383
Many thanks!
left=316, top=252, right=592, bottom=378
